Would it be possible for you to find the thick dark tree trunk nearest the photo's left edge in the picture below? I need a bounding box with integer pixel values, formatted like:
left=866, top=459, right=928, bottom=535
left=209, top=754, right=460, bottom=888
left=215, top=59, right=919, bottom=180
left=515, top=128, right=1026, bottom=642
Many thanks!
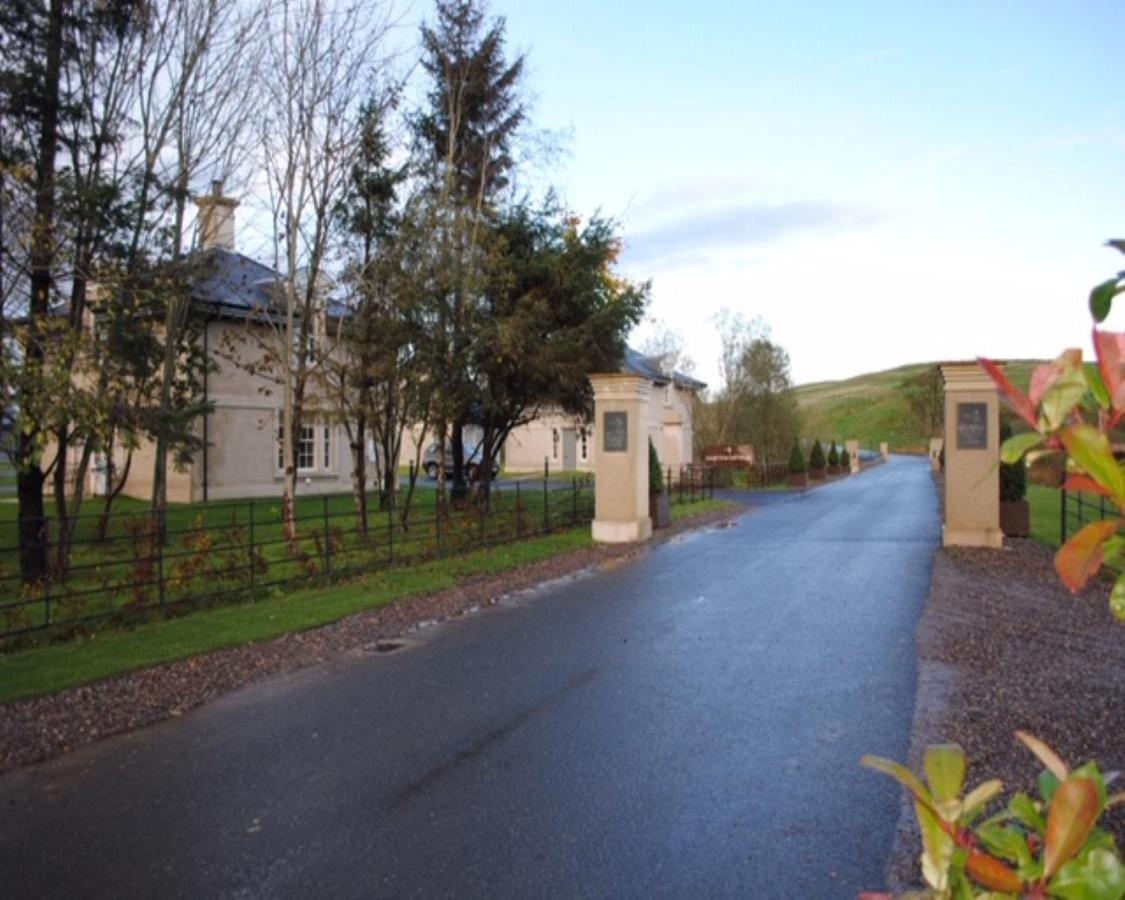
left=16, top=0, right=64, bottom=583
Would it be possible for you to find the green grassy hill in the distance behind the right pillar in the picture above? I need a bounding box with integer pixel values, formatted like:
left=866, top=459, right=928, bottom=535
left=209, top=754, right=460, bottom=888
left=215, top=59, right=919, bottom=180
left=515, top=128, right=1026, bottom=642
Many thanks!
left=795, top=360, right=1036, bottom=453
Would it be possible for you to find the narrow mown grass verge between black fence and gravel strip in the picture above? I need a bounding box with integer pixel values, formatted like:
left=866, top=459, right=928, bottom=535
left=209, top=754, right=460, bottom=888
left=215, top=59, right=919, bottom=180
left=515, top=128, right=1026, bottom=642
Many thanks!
left=0, top=500, right=731, bottom=702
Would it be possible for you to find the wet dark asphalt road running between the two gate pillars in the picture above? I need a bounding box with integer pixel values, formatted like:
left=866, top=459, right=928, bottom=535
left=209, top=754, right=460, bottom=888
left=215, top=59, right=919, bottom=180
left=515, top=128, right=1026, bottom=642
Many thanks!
left=0, top=458, right=939, bottom=898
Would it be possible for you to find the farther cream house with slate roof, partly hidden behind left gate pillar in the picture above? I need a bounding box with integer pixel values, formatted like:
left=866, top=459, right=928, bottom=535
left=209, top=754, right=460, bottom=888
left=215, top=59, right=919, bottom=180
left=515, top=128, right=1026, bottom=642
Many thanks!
left=504, top=349, right=707, bottom=473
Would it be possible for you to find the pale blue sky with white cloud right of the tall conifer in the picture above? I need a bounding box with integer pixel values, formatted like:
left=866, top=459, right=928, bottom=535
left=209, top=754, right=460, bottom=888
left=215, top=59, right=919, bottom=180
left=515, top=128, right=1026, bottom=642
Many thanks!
left=481, top=0, right=1125, bottom=384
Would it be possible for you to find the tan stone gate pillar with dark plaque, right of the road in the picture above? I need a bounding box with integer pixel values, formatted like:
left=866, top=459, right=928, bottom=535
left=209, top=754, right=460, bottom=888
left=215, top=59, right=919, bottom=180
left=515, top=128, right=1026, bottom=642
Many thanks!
left=942, top=362, right=1004, bottom=547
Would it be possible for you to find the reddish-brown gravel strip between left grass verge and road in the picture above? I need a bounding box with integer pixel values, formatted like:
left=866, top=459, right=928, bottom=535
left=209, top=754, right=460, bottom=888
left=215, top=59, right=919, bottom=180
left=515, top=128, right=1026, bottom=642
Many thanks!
left=0, top=510, right=739, bottom=773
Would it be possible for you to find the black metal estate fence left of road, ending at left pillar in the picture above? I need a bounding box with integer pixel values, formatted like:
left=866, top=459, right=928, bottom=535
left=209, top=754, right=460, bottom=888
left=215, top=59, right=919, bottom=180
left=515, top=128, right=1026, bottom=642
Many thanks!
left=0, top=477, right=594, bottom=642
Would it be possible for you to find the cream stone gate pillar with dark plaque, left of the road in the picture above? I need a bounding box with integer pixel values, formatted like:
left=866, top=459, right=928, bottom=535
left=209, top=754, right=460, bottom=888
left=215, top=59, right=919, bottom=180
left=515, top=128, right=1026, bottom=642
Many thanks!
left=590, top=374, right=653, bottom=543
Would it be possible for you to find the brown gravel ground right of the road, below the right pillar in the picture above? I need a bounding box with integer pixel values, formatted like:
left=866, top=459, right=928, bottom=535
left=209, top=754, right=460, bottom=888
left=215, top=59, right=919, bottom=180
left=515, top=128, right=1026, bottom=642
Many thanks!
left=888, top=539, right=1125, bottom=891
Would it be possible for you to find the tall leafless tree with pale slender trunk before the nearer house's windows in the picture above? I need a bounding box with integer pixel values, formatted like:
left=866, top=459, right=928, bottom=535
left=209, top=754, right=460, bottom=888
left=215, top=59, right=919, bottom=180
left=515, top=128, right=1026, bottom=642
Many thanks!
left=246, top=0, right=390, bottom=540
